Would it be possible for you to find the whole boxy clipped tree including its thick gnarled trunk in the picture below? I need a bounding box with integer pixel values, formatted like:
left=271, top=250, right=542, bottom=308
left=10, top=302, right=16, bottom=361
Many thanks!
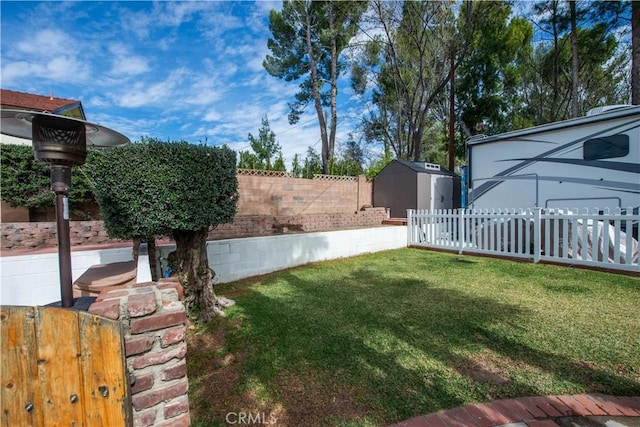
left=87, top=139, right=238, bottom=321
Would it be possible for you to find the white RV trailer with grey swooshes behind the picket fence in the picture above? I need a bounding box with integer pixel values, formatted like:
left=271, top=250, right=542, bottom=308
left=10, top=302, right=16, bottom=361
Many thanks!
left=467, top=106, right=640, bottom=213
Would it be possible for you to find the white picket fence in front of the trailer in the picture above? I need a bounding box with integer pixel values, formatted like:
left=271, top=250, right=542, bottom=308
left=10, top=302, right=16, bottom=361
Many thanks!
left=407, top=209, right=640, bottom=272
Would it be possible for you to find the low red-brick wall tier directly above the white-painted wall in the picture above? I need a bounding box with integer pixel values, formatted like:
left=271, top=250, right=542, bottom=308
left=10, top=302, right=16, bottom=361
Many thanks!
left=0, top=208, right=387, bottom=251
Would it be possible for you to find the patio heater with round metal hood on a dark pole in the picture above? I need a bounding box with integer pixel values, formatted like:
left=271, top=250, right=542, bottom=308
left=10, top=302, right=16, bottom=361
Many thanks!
left=0, top=110, right=131, bottom=307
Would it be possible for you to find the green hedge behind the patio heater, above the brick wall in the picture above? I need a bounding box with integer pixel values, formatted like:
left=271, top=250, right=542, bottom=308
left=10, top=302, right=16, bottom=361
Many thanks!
left=0, top=144, right=93, bottom=214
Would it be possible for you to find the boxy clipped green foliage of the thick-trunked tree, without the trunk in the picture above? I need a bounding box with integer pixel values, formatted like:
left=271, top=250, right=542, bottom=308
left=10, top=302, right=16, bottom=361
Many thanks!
left=85, top=139, right=238, bottom=240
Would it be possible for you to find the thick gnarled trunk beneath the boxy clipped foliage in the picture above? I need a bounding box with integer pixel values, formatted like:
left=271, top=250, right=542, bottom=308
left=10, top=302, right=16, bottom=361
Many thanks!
left=169, top=228, right=232, bottom=322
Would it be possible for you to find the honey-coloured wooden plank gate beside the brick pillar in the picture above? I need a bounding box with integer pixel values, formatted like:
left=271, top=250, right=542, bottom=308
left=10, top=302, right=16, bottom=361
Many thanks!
left=0, top=306, right=132, bottom=427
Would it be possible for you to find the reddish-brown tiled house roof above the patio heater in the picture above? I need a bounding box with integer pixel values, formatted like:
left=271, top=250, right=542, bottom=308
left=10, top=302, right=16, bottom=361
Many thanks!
left=0, top=89, right=86, bottom=120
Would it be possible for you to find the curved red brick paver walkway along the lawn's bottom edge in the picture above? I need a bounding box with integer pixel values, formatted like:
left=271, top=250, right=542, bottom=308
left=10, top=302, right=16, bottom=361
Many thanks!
left=395, top=394, right=640, bottom=427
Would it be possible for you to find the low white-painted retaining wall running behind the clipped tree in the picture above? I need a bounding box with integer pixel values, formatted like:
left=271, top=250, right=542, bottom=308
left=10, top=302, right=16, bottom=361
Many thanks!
left=0, top=226, right=407, bottom=305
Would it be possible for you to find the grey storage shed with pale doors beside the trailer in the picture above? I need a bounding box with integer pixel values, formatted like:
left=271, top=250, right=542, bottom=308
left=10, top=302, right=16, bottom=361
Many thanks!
left=373, top=160, right=461, bottom=218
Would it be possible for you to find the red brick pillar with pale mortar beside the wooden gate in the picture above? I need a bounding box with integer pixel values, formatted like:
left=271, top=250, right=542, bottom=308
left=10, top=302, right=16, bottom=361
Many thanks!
left=89, top=278, right=190, bottom=427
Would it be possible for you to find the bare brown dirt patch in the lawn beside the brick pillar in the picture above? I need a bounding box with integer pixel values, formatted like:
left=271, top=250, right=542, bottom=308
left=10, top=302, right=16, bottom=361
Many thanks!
left=187, top=319, right=370, bottom=427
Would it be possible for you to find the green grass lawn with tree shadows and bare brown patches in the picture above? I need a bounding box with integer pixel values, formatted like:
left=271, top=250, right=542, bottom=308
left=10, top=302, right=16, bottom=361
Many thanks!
left=187, top=249, right=640, bottom=426
